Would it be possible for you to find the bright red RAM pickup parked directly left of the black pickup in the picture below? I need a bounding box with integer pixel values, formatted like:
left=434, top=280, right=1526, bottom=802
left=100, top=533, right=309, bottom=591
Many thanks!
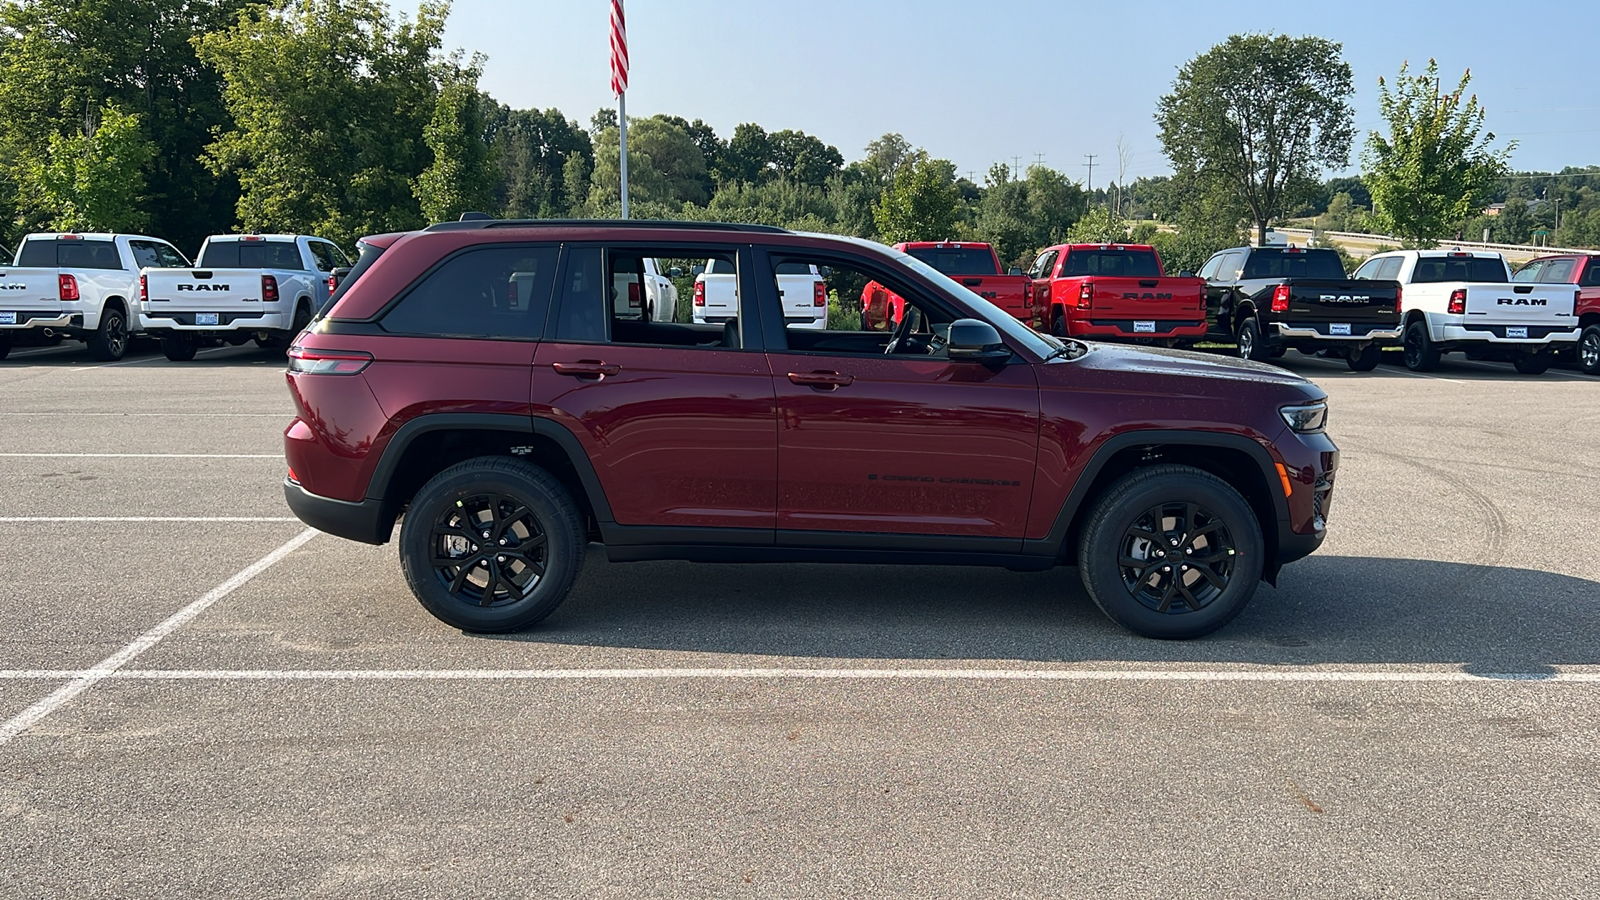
left=1029, top=243, right=1206, bottom=346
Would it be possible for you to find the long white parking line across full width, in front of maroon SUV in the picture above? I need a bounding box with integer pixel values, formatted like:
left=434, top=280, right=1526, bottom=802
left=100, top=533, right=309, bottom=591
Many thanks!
left=0, top=668, right=1600, bottom=679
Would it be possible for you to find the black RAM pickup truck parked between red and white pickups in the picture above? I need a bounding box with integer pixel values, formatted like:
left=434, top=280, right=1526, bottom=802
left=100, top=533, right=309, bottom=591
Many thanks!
left=1200, top=247, right=1400, bottom=372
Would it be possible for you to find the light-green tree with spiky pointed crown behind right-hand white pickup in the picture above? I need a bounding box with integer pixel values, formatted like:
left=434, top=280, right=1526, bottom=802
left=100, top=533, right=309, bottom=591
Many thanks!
left=1362, top=59, right=1517, bottom=247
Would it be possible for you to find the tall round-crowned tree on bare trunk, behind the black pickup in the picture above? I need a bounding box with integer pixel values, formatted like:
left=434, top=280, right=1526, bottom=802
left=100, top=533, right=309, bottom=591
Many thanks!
left=1155, top=35, right=1355, bottom=242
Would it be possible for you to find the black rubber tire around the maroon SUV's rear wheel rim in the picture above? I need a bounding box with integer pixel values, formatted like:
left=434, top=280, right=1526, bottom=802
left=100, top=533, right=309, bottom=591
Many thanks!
left=400, top=460, right=586, bottom=633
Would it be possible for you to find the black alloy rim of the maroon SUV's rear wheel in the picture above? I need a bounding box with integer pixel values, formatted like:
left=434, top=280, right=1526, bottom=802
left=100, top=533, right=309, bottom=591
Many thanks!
left=430, top=493, right=550, bottom=607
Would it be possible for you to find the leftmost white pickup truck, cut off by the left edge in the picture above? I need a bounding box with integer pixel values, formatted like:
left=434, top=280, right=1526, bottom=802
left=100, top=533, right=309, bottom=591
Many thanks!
left=0, top=234, right=189, bottom=362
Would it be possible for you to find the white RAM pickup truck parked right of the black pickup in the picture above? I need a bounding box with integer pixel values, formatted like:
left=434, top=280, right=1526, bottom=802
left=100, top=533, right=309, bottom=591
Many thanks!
left=1354, top=250, right=1579, bottom=375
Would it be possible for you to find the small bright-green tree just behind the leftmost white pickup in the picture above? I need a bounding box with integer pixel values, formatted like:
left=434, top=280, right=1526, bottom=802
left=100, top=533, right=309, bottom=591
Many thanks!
left=34, top=104, right=155, bottom=231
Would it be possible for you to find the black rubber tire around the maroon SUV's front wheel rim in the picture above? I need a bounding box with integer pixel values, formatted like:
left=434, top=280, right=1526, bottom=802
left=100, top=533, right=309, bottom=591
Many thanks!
left=1078, top=468, right=1266, bottom=641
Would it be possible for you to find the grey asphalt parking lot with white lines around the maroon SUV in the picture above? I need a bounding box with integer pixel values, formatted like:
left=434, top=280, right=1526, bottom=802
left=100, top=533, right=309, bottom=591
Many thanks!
left=0, top=344, right=1600, bottom=898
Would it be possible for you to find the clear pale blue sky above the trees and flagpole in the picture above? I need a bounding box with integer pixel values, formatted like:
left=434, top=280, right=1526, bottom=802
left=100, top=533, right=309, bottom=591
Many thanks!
left=428, top=0, right=1600, bottom=186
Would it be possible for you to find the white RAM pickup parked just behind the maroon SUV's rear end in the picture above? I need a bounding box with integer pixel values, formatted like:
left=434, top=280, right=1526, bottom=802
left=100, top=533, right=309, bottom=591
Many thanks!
left=139, top=234, right=350, bottom=360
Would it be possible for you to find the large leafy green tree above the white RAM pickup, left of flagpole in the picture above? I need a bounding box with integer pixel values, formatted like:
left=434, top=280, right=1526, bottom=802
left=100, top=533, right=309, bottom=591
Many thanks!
left=197, top=0, right=450, bottom=243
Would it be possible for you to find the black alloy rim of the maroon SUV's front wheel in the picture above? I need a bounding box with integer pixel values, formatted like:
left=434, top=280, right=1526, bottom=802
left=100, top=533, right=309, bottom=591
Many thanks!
left=1117, top=503, right=1238, bottom=615
